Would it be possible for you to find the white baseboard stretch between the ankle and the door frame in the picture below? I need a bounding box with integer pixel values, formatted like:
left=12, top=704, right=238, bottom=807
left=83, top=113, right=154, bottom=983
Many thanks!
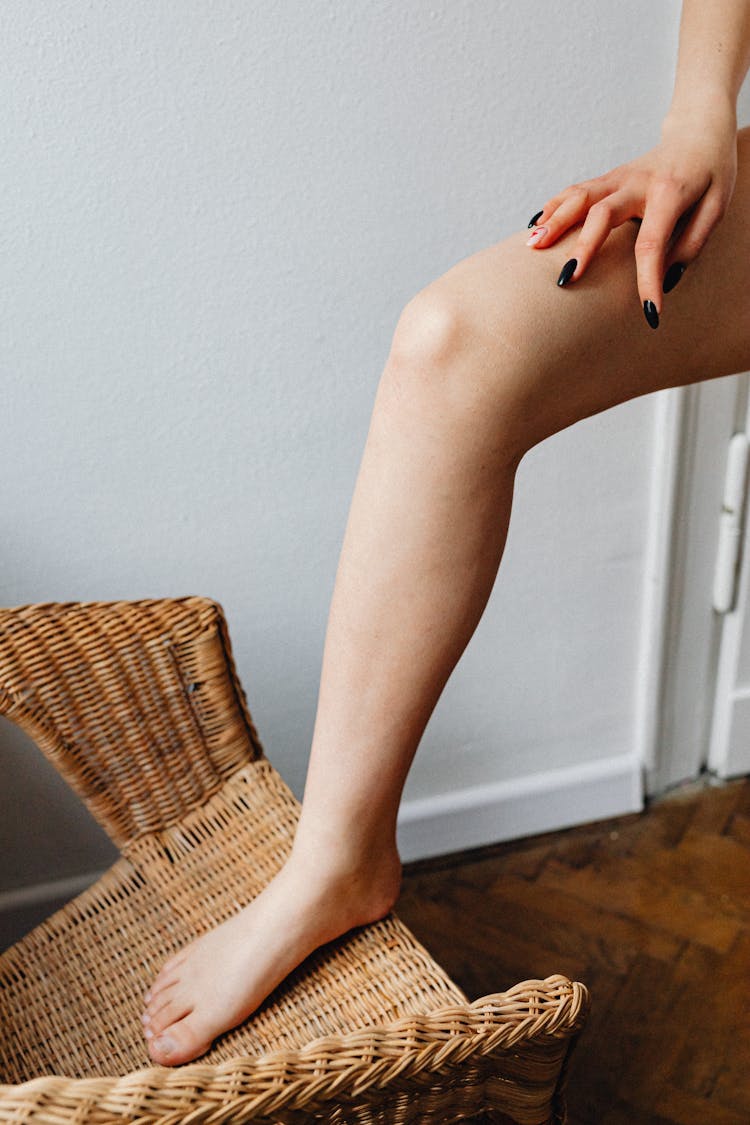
left=398, top=755, right=643, bottom=862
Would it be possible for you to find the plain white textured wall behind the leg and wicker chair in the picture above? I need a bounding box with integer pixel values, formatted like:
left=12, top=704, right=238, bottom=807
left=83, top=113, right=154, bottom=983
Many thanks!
left=0, top=0, right=733, bottom=922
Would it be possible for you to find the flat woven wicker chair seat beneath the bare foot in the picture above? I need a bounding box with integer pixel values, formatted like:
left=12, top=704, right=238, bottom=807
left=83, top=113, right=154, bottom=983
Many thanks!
left=0, top=759, right=467, bottom=1082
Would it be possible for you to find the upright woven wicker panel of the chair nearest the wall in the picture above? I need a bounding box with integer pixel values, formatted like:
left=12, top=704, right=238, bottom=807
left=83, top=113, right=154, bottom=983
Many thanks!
left=0, top=596, right=263, bottom=846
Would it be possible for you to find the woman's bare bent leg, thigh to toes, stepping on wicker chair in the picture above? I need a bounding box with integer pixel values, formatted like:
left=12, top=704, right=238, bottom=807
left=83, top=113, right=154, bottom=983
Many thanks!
left=139, top=129, right=750, bottom=1064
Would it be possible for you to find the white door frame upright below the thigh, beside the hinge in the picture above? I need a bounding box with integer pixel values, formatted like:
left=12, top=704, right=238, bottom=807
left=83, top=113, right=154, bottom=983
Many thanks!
left=635, top=375, right=748, bottom=795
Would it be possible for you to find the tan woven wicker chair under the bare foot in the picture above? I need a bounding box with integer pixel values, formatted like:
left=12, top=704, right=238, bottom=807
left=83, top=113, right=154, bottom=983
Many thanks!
left=0, top=596, right=589, bottom=1125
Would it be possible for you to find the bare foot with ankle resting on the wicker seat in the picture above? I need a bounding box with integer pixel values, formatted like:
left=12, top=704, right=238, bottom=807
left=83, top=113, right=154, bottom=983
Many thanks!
left=141, top=849, right=400, bottom=1067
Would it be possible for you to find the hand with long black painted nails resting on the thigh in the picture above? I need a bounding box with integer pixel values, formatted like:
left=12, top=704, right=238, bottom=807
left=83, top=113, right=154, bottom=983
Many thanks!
left=528, top=107, right=737, bottom=329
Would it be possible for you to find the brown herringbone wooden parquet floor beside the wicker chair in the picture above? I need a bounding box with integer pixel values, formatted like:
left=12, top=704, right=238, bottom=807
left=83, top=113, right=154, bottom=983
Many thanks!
left=396, top=779, right=750, bottom=1125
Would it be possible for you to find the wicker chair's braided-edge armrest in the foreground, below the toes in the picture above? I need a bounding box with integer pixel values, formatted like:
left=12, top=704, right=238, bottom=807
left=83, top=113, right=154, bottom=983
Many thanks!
left=0, top=975, right=589, bottom=1125
